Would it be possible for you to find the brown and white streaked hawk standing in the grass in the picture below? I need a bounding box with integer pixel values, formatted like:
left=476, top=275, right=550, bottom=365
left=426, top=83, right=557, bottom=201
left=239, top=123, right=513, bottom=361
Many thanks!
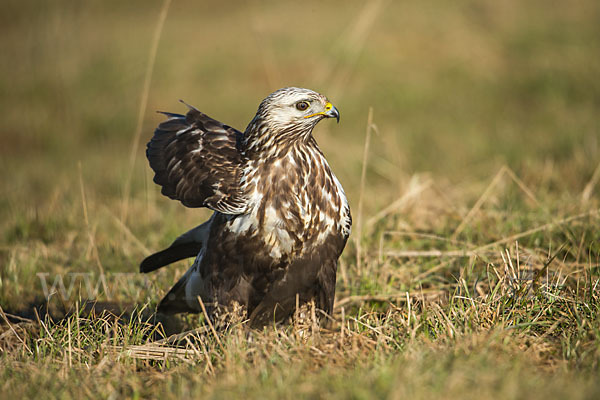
left=140, top=87, right=352, bottom=327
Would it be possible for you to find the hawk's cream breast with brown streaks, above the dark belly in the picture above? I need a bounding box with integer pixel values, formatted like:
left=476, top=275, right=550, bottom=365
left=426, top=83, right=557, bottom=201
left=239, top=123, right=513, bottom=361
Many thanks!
left=227, top=145, right=349, bottom=260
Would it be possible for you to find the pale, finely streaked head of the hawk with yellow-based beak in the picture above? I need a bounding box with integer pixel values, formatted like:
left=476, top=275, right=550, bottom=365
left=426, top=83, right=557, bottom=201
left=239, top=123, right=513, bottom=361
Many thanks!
left=245, top=87, right=340, bottom=155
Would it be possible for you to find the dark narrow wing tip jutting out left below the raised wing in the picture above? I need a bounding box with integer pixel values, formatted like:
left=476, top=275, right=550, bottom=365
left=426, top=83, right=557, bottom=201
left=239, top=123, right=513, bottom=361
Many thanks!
left=140, top=220, right=211, bottom=273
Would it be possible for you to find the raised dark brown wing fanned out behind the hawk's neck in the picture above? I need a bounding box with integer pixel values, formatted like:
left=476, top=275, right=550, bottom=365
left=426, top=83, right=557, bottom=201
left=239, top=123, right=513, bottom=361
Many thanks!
left=146, top=106, right=246, bottom=214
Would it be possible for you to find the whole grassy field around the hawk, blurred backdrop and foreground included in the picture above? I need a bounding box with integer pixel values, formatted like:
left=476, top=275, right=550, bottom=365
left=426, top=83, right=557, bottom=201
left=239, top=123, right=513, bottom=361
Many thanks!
left=0, top=0, right=600, bottom=399
